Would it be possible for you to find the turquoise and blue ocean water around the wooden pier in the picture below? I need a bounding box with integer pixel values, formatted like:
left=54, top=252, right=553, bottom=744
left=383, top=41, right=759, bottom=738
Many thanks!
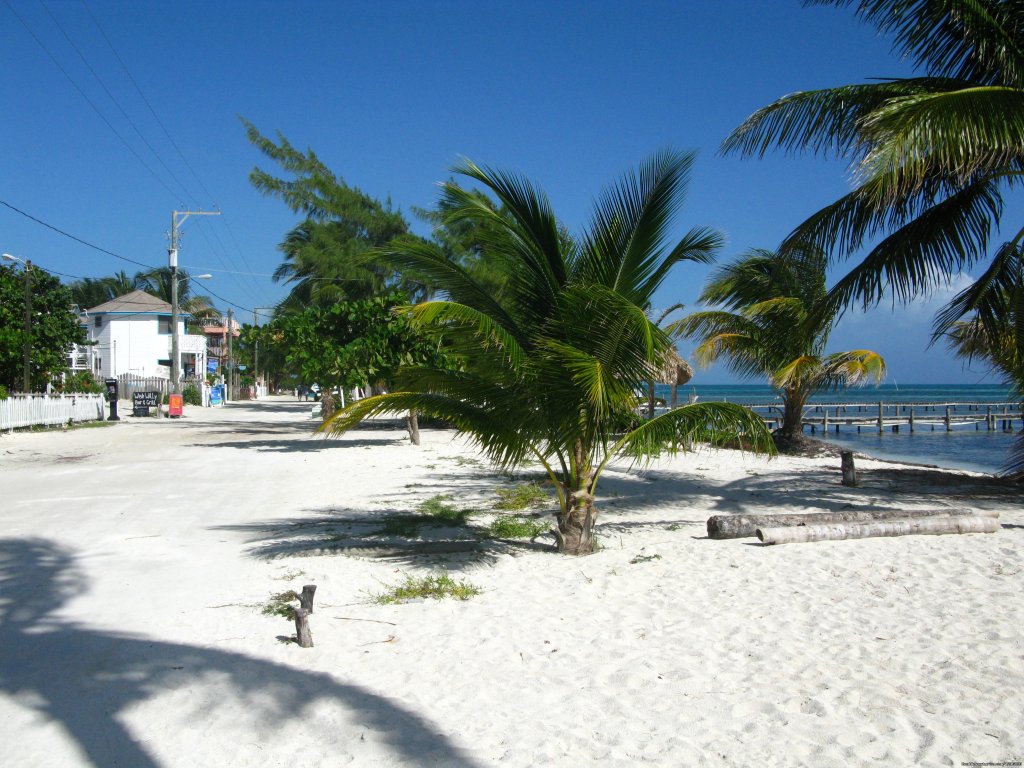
left=656, top=384, right=1021, bottom=473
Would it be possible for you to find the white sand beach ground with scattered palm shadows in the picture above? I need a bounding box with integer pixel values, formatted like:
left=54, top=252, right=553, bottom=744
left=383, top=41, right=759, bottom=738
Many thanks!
left=0, top=398, right=1024, bottom=768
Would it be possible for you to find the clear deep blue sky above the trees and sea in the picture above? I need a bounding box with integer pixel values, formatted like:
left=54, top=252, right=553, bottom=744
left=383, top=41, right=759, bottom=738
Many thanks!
left=0, top=0, right=1003, bottom=384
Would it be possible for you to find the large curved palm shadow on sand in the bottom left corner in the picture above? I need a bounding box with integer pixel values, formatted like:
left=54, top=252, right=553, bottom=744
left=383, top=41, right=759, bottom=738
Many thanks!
left=0, top=539, right=475, bottom=768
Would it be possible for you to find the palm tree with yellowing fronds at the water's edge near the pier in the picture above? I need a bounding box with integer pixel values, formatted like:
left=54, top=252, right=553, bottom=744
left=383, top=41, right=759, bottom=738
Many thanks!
left=669, top=248, right=885, bottom=447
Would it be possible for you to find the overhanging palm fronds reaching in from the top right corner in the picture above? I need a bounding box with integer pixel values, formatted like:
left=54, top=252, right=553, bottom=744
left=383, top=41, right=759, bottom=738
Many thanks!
left=723, top=0, right=1024, bottom=370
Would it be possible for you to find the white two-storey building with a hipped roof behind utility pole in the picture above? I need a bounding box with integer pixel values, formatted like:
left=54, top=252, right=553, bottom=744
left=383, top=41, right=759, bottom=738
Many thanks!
left=79, top=291, right=207, bottom=379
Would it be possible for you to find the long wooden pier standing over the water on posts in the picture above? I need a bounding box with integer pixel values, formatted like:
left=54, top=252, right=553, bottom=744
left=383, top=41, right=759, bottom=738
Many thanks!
left=740, top=402, right=1024, bottom=434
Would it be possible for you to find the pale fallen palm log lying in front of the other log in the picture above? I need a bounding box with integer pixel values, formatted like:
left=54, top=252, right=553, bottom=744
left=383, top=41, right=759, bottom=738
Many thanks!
left=756, top=516, right=999, bottom=544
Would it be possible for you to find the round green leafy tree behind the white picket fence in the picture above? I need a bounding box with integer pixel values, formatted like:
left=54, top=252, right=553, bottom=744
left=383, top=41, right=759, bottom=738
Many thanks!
left=0, top=265, right=86, bottom=392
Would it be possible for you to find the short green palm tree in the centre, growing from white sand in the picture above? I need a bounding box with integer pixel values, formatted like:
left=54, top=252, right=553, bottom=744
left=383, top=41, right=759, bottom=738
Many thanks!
left=323, top=152, right=771, bottom=554
